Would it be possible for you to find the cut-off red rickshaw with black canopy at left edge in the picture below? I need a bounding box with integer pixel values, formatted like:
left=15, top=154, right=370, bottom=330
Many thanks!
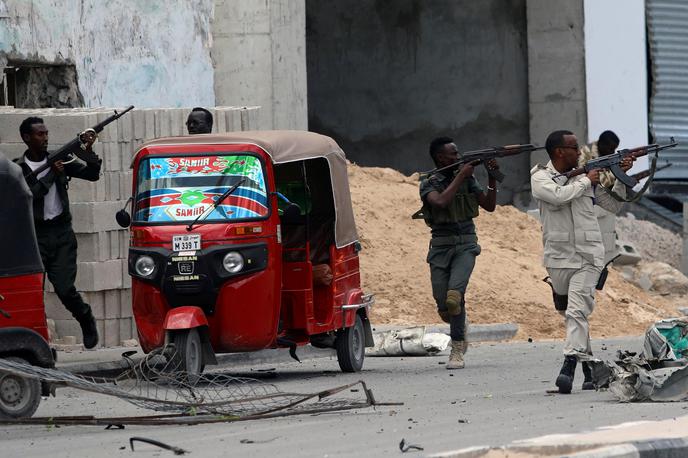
left=0, top=153, right=55, bottom=418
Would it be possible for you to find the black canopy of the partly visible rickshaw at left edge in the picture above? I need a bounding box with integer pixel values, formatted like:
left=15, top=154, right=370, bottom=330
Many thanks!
left=0, top=153, right=43, bottom=277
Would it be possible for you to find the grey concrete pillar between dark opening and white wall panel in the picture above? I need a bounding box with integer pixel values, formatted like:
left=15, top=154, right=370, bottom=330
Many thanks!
left=527, top=0, right=584, bottom=168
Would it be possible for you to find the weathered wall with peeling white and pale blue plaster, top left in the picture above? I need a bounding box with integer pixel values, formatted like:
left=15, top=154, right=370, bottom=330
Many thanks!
left=0, top=0, right=215, bottom=107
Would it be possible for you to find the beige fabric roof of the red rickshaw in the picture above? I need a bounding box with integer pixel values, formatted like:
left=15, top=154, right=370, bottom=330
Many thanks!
left=137, top=130, right=358, bottom=248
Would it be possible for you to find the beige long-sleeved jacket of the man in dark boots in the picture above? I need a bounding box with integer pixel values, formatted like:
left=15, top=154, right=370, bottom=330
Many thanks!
left=530, top=161, right=623, bottom=269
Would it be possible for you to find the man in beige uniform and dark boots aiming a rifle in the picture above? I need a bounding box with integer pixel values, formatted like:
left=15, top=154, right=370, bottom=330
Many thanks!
left=530, top=130, right=632, bottom=393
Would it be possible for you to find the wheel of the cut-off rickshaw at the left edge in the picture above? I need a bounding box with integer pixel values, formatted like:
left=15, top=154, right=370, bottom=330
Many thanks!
left=0, top=356, right=41, bottom=419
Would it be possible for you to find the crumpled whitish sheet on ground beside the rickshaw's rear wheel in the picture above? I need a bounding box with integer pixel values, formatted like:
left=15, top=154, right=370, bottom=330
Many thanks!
left=365, top=326, right=451, bottom=356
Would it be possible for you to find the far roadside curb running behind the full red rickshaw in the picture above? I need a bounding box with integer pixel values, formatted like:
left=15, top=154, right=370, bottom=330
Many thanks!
left=57, top=323, right=518, bottom=377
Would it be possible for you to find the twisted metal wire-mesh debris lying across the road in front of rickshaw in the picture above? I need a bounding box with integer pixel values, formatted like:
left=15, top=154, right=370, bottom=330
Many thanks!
left=0, top=347, right=390, bottom=424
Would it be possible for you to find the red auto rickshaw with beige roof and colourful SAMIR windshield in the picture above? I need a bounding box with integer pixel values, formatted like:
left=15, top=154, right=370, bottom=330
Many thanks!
left=117, top=131, right=374, bottom=374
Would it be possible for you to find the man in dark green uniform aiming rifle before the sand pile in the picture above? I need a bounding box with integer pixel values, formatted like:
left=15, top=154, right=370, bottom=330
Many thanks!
left=414, top=137, right=499, bottom=369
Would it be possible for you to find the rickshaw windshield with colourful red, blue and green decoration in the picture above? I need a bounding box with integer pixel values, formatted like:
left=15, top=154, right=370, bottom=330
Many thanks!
left=134, top=153, right=269, bottom=224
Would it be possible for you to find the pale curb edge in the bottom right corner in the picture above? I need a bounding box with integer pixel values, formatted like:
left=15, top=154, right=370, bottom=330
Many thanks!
left=430, top=437, right=688, bottom=458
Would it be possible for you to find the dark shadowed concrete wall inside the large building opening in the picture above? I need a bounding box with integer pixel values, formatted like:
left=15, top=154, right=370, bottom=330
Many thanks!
left=306, top=0, right=529, bottom=202
